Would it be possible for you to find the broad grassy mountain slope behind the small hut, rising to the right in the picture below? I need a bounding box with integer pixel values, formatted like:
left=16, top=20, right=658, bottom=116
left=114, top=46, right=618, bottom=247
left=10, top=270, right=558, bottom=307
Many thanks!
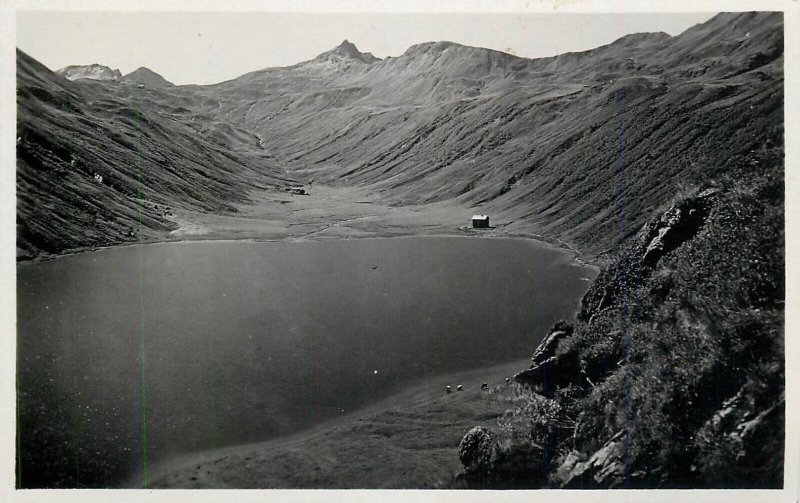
left=191, top=13, right=783, bottom=253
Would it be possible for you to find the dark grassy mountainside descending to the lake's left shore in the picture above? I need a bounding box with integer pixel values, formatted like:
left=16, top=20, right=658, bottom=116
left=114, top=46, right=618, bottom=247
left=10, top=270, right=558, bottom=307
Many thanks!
left=17, top=51, right=284, bottom=257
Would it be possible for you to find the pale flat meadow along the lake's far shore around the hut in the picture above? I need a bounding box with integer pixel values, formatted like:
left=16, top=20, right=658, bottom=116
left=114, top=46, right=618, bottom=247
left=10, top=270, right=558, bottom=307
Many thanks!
left=16, top=185, right=599, bottom=271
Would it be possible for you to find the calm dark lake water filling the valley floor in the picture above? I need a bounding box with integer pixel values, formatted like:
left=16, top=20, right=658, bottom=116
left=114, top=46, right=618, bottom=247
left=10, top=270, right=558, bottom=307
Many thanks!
left=17, top=237, right=593, bottom=487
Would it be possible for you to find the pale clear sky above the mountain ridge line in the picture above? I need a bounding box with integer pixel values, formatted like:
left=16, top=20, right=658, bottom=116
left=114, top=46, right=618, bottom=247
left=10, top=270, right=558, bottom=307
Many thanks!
left=16, top=11, right=713, bottom=84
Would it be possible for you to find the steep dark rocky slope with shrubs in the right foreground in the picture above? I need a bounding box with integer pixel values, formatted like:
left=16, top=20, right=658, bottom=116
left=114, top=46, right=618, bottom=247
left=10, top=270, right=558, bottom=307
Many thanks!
left=461, top=158, right=785, bottom=489
